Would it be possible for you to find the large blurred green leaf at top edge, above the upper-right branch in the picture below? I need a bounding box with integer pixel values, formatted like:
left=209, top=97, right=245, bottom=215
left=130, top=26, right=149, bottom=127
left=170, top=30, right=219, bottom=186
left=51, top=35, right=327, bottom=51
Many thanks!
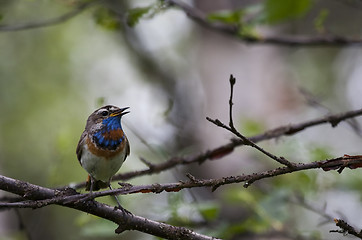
left=264, top=0, right=312, bottom=24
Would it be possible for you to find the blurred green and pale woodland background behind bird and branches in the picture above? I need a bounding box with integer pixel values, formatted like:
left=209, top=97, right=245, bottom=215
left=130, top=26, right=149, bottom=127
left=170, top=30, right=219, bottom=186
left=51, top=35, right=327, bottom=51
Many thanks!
left=0, top=0, right=362, bottom=239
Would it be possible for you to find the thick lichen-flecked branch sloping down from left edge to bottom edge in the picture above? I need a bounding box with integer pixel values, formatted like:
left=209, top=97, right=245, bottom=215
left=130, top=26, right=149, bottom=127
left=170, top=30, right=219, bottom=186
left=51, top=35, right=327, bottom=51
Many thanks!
left=0, top=175, right=216, bottom=240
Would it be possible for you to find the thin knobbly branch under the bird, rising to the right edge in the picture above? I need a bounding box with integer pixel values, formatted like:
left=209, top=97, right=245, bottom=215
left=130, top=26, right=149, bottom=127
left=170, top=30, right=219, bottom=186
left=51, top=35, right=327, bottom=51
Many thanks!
left=6, top=155, right=362, bottom=206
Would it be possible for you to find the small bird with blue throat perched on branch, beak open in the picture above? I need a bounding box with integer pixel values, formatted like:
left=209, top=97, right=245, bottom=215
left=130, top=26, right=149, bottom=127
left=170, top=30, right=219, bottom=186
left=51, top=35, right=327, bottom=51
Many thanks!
left=76, top=105, right=130, bottom=209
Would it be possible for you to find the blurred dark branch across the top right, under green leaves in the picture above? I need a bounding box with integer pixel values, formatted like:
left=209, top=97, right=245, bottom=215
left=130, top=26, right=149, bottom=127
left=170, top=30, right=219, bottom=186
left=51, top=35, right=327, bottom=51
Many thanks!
left=167, top=0, right=362, bottom=47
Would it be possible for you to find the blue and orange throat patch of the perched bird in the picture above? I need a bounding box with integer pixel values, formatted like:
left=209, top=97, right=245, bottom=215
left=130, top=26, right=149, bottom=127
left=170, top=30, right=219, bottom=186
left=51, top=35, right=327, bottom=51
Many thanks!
left=93, top=117, right=125, bottom=150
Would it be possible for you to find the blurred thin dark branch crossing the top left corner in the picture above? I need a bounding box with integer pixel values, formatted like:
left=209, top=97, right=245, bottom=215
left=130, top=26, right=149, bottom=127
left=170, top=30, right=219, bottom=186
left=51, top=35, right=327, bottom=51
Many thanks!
left=0, top=0, right=102, bottom=32
